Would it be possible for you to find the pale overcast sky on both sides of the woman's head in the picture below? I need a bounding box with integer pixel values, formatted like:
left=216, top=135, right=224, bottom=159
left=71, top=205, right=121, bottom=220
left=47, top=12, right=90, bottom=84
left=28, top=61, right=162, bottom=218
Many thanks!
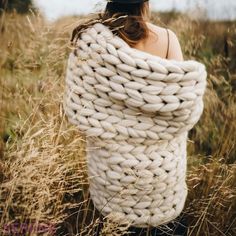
left=34, top=0, right=236, bottom=20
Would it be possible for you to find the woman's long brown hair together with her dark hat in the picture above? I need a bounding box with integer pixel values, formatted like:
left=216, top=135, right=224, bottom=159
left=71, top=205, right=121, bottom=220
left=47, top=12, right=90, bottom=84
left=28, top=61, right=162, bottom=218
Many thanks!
left=71, top=2, right=149, bottom=46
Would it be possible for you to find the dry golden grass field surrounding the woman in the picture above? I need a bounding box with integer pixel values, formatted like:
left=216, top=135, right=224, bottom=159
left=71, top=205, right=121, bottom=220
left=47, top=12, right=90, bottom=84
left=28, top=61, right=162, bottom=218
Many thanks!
left=0, top=4, right=236, bottom=236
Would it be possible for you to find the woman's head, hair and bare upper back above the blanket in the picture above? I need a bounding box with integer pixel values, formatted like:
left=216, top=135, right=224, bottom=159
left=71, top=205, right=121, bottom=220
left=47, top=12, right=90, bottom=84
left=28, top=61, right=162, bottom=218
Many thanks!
left=71, top=0, right=183, bottom=61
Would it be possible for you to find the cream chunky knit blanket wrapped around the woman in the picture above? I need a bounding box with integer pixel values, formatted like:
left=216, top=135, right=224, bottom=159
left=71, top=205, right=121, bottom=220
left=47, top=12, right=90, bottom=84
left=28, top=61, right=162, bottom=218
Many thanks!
left=63, top=23, right=207, bottom=227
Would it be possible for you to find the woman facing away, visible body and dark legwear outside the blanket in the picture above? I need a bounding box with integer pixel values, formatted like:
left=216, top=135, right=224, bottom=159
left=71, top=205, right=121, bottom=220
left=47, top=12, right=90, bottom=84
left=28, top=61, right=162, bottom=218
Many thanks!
left=71, top=0, right=187, bottom=235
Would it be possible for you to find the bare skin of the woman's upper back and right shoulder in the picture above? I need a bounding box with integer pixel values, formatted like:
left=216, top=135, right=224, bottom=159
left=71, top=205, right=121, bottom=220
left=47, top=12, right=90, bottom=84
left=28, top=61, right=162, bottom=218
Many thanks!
left=135, top=2, right=184, bottom=61
